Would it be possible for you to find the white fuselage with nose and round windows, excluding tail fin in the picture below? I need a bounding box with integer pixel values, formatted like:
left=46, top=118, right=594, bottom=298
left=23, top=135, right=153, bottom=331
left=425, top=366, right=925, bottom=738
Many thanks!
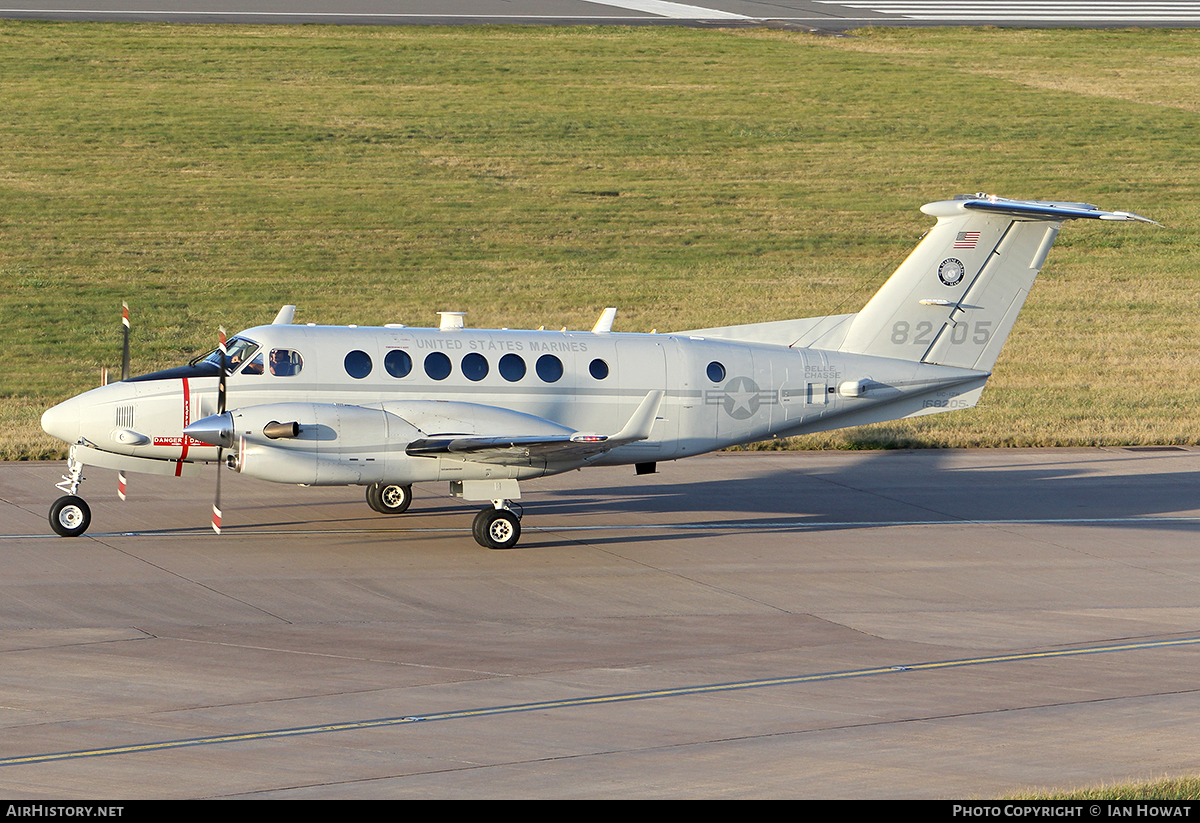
left=43, top=325, right=988, bottom=485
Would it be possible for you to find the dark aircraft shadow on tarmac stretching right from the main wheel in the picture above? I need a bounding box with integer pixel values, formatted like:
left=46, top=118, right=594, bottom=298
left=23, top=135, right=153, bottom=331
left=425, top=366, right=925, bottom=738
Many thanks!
left=527, top=450, right=1200, bottom=530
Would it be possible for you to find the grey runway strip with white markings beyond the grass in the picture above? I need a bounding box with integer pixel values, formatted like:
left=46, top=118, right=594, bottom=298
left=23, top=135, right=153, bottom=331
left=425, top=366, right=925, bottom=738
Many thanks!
left=7, top=0, right=1200, bottom=31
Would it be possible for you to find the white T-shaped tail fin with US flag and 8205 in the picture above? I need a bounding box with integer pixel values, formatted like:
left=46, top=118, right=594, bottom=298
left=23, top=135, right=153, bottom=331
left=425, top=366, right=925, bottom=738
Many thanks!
left=841, top=194, right=1154, bottom=372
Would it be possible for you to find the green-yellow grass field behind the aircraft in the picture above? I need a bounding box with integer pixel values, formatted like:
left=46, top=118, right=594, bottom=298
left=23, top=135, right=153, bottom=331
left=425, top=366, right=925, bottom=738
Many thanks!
left=0, top=22, right=1200, bottom=459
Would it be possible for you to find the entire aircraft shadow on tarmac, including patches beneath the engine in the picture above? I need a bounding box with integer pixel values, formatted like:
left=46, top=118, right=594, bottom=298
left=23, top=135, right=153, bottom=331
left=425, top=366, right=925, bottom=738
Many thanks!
left=206, top=450, right=1200, bottom=548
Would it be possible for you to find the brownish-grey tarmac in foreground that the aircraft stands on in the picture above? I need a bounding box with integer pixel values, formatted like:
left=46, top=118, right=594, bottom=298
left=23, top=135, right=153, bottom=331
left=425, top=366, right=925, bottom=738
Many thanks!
left=0, top=449, right=1200, bottom=800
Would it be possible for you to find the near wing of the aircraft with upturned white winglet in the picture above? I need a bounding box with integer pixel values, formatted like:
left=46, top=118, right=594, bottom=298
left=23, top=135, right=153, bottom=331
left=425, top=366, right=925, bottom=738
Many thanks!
left=404, top=391, right=665, bottom=464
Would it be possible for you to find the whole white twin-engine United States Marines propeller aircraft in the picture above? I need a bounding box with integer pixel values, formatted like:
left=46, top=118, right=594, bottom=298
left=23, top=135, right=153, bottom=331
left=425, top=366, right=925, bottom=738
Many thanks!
left=42, top=194, right=1153, bottom=548
